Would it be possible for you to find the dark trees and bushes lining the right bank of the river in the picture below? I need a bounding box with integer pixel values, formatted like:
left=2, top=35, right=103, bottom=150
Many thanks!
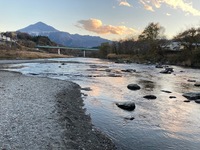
left=99, top=23, right=200, bottom=68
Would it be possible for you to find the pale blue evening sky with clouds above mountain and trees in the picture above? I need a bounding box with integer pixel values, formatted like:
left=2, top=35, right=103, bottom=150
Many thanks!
left=0, top=0, right=200, bottom=40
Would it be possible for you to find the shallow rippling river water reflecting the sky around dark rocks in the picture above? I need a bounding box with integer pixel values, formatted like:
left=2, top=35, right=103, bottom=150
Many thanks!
left=3, top=58, right=200, bottom=150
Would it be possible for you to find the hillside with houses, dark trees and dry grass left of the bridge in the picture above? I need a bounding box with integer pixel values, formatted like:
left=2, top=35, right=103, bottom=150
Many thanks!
left=0, top=32, right=68, bottom=59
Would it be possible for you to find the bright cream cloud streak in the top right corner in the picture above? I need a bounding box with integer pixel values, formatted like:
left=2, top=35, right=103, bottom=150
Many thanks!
left=140, top=0, right=200, bottom=16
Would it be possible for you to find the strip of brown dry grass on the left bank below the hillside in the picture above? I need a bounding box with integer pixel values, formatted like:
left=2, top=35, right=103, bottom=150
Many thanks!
left=0, top=50, right=69, bottom=59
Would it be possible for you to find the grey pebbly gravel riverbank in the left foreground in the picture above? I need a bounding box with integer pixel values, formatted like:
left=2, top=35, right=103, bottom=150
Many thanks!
left=0, top=71, right=115, bottom=150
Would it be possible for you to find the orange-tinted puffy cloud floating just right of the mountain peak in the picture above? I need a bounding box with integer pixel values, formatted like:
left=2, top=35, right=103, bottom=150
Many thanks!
left=76, top=19, right=136, bottom=35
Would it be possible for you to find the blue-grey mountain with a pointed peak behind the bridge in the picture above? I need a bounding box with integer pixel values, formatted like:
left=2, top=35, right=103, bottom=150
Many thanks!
left=18, top=22, right=111, bottom=47
